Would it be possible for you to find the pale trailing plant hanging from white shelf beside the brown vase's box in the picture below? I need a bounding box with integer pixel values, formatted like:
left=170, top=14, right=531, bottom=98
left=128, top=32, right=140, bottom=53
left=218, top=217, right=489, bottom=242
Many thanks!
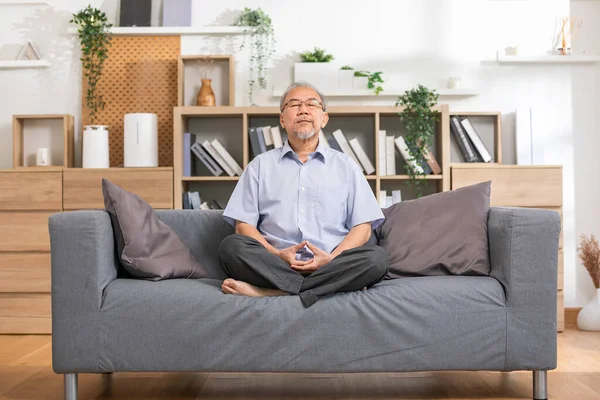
left=233, top=7, right=275, bottom=105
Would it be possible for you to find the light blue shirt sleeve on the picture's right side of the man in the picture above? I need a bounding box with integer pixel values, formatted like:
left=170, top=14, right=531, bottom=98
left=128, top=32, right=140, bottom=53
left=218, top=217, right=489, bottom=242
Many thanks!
left=346, top=160, right=385, bottom=229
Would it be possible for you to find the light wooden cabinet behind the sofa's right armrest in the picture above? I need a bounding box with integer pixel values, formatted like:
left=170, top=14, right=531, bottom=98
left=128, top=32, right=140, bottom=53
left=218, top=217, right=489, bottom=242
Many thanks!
left=451, top=164, right=565, bottom=332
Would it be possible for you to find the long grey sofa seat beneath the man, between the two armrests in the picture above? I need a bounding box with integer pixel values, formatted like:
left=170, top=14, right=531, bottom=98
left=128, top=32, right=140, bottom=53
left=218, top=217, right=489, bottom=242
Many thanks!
left=98, top=276, right=506, bottom=372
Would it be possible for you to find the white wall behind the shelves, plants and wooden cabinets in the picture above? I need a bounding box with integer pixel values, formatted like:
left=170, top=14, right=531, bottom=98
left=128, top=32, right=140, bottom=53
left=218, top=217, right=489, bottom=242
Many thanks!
left=0, top=0, right=600, bottom=307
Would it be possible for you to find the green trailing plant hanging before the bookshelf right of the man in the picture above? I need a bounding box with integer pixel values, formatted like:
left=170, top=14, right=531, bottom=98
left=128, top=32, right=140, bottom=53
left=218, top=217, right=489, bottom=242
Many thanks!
left=396, top=85, right=439, bottom=198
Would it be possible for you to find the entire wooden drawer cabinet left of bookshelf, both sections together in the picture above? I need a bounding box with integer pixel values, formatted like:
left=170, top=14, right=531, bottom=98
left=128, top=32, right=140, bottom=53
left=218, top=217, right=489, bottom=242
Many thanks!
left=0, top=167, right=173, bottom=334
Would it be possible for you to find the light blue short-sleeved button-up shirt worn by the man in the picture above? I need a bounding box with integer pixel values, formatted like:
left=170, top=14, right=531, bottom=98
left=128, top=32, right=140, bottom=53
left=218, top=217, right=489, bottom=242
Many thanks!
left=223, top=141, right=384, bottom=253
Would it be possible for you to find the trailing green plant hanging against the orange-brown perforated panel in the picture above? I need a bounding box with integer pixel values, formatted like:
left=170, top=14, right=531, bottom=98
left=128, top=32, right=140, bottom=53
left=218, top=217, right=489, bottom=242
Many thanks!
left=69, top=5, right=112, bottom=125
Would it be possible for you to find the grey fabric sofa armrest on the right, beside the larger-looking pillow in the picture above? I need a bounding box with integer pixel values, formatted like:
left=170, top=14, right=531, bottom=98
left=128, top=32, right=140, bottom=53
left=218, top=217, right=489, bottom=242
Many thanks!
left=488, top=207, right=561, bottom=370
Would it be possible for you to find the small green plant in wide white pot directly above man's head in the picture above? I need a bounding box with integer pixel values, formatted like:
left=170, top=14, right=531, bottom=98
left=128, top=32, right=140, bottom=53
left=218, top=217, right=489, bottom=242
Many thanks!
left=294, top=47, right=337, bottom=90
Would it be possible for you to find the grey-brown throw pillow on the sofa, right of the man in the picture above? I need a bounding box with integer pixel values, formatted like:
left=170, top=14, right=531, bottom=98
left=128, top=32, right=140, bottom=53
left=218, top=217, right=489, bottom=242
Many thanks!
left=375, top=181, right=491, bottom=279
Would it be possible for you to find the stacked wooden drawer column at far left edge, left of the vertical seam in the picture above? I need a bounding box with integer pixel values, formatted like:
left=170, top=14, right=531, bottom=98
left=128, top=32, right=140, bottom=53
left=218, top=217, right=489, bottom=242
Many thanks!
left=0, top=167, right=62, bottom=333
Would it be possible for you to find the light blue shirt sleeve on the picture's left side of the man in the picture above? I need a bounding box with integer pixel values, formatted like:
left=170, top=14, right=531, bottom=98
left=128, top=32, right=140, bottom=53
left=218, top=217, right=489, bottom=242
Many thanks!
left=223, top=162, right=259, bottom=227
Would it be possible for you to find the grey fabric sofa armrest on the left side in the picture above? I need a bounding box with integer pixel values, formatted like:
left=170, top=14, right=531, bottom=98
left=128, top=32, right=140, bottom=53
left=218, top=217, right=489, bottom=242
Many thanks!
left=49, top=210, right=118, bottom=373
